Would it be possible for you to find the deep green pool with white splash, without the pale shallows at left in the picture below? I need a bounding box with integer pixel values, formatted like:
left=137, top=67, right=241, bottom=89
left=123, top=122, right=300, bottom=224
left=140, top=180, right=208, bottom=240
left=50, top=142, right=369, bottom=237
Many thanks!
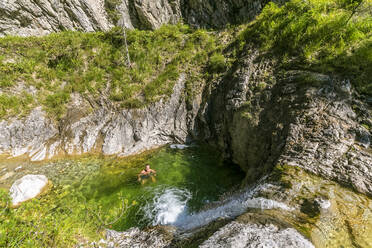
left=77, top=147, right=243, bottom=230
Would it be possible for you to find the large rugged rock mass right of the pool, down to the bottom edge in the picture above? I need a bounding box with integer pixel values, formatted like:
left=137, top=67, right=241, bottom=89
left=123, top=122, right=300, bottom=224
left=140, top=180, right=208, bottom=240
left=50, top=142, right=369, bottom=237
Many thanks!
left=91, top=49, right=372, bottom=247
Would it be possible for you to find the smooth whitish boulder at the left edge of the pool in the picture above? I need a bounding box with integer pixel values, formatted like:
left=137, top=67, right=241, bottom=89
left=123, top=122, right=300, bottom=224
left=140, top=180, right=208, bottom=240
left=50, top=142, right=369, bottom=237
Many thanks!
left=10, top=175, right=48, bottom=205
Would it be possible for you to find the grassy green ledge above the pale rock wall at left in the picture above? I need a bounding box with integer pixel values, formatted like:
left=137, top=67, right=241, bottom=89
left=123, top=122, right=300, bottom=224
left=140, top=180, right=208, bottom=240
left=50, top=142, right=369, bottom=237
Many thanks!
left=0, top=25, right=220, bottom=119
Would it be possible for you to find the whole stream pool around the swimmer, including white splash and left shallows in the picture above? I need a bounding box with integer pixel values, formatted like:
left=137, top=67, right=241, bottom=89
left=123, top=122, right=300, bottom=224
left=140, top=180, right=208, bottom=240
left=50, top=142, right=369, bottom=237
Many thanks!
left=0, top=146, right=244, bottom=231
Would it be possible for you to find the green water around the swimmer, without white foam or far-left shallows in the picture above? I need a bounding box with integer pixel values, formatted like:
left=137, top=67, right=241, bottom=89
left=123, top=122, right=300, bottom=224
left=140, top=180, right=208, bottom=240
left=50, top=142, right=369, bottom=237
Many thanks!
left=40, top=147, right=243, bottom=230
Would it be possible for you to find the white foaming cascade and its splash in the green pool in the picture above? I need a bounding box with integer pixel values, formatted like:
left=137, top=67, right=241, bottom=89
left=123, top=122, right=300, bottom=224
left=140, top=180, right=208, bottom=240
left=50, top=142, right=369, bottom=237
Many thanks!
left=143, top=184, right=293, bottom=231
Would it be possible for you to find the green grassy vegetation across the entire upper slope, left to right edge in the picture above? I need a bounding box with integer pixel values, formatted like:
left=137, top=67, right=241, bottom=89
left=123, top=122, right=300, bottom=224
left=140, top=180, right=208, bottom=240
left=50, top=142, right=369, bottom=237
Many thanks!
left=0, top=0, right=372, bottom=119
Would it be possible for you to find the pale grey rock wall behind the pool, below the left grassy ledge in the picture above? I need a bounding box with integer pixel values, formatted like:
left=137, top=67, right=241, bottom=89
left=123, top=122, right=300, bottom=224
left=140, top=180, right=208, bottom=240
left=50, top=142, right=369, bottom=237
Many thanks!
left=0, top=75, right=198, bottom=161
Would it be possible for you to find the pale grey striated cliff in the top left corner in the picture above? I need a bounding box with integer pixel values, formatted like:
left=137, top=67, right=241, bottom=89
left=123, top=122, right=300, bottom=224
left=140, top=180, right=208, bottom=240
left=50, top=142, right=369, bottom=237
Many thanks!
left=0, top=0, right=112, bottom=36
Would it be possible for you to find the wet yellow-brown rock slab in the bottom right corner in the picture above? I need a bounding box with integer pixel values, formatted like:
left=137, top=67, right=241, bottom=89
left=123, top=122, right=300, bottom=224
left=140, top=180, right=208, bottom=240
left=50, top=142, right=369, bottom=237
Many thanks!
left=258, top=165, right=372, bottom=247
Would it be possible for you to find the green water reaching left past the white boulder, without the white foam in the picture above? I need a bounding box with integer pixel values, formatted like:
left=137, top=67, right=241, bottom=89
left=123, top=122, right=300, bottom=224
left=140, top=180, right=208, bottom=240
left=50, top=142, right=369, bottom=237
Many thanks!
left=2, top=146, right=244, bottom=230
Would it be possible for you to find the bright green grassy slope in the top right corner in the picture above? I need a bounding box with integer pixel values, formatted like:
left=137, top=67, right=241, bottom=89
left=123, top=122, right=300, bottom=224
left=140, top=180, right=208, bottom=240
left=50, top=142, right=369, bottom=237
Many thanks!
left=240, top=0, right=372, bottom=95
